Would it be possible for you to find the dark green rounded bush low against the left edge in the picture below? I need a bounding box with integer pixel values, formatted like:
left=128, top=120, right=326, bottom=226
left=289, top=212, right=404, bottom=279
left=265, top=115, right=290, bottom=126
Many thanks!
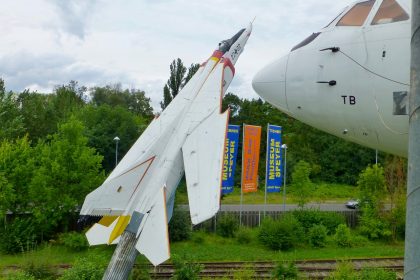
left=0, top=217, right=39, bottom=254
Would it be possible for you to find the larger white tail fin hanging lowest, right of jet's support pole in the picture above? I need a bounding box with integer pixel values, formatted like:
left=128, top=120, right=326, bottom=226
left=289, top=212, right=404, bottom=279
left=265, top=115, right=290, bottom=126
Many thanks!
left=136, top=187, right=170, bottom=266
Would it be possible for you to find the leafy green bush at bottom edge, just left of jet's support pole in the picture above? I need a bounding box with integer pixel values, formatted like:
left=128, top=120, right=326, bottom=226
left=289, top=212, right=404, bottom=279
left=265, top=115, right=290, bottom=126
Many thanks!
left=59, top=257, right=106, bottom=280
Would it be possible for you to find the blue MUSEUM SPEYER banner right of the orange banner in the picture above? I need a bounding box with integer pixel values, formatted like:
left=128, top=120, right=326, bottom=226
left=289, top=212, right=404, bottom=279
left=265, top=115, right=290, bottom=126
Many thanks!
left=265, top=125, right=283, bottom=192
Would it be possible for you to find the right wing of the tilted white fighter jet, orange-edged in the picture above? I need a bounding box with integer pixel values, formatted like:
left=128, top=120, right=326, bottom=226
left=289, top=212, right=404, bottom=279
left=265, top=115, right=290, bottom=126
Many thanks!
left=182, top=60, right=229, bottom=224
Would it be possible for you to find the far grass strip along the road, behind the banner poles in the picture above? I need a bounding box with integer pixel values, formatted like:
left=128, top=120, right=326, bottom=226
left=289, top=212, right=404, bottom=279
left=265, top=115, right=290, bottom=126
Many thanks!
left=176, top=183, right=359, bottom=204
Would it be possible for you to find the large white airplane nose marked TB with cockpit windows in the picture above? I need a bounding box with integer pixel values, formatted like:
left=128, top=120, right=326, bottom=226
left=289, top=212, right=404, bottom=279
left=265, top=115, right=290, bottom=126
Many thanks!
left=252, top=0, right=411, bottom=157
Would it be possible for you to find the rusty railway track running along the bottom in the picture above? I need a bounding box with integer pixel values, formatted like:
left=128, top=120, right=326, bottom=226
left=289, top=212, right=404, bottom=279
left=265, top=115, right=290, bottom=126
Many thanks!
left=141, top=258, right=404, bottom=279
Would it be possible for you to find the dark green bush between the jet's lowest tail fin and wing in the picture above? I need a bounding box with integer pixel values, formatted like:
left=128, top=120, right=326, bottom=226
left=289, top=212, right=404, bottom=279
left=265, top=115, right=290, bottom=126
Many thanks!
left=169, top=207, right=192, bottom=242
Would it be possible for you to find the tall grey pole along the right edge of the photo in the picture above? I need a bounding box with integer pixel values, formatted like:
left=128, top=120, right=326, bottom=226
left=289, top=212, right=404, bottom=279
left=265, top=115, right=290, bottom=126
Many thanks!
left=404, top=0, right=420, bottom=280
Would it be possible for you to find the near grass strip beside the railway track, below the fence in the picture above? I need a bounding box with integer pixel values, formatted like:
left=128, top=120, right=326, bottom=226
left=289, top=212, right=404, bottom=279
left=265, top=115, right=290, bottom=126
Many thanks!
left=0, top=229, right=404, bottom=274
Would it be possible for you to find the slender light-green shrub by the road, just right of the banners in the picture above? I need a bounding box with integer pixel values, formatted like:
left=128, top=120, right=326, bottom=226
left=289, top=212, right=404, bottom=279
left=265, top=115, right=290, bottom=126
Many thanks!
left=292, top=160, right=312, bottom=208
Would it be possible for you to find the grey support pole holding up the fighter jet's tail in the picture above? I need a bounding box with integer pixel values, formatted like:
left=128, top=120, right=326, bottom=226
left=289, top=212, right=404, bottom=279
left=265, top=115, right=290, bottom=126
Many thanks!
left=102, top=231, right=139, bottom=280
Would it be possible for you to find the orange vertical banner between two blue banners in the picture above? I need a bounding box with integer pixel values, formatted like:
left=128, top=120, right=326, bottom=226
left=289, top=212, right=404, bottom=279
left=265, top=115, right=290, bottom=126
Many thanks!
left=242, top=125, right=261, bottom=193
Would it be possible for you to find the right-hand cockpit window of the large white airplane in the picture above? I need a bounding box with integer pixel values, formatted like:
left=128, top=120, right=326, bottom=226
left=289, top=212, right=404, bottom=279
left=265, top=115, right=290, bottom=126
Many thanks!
left=372, top=0, right=409, bottom=25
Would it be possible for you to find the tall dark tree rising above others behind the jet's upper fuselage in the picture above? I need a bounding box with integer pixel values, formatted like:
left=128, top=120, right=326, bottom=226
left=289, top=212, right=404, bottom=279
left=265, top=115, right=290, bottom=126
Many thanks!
left=160, top=58, right=200, bottom=110
